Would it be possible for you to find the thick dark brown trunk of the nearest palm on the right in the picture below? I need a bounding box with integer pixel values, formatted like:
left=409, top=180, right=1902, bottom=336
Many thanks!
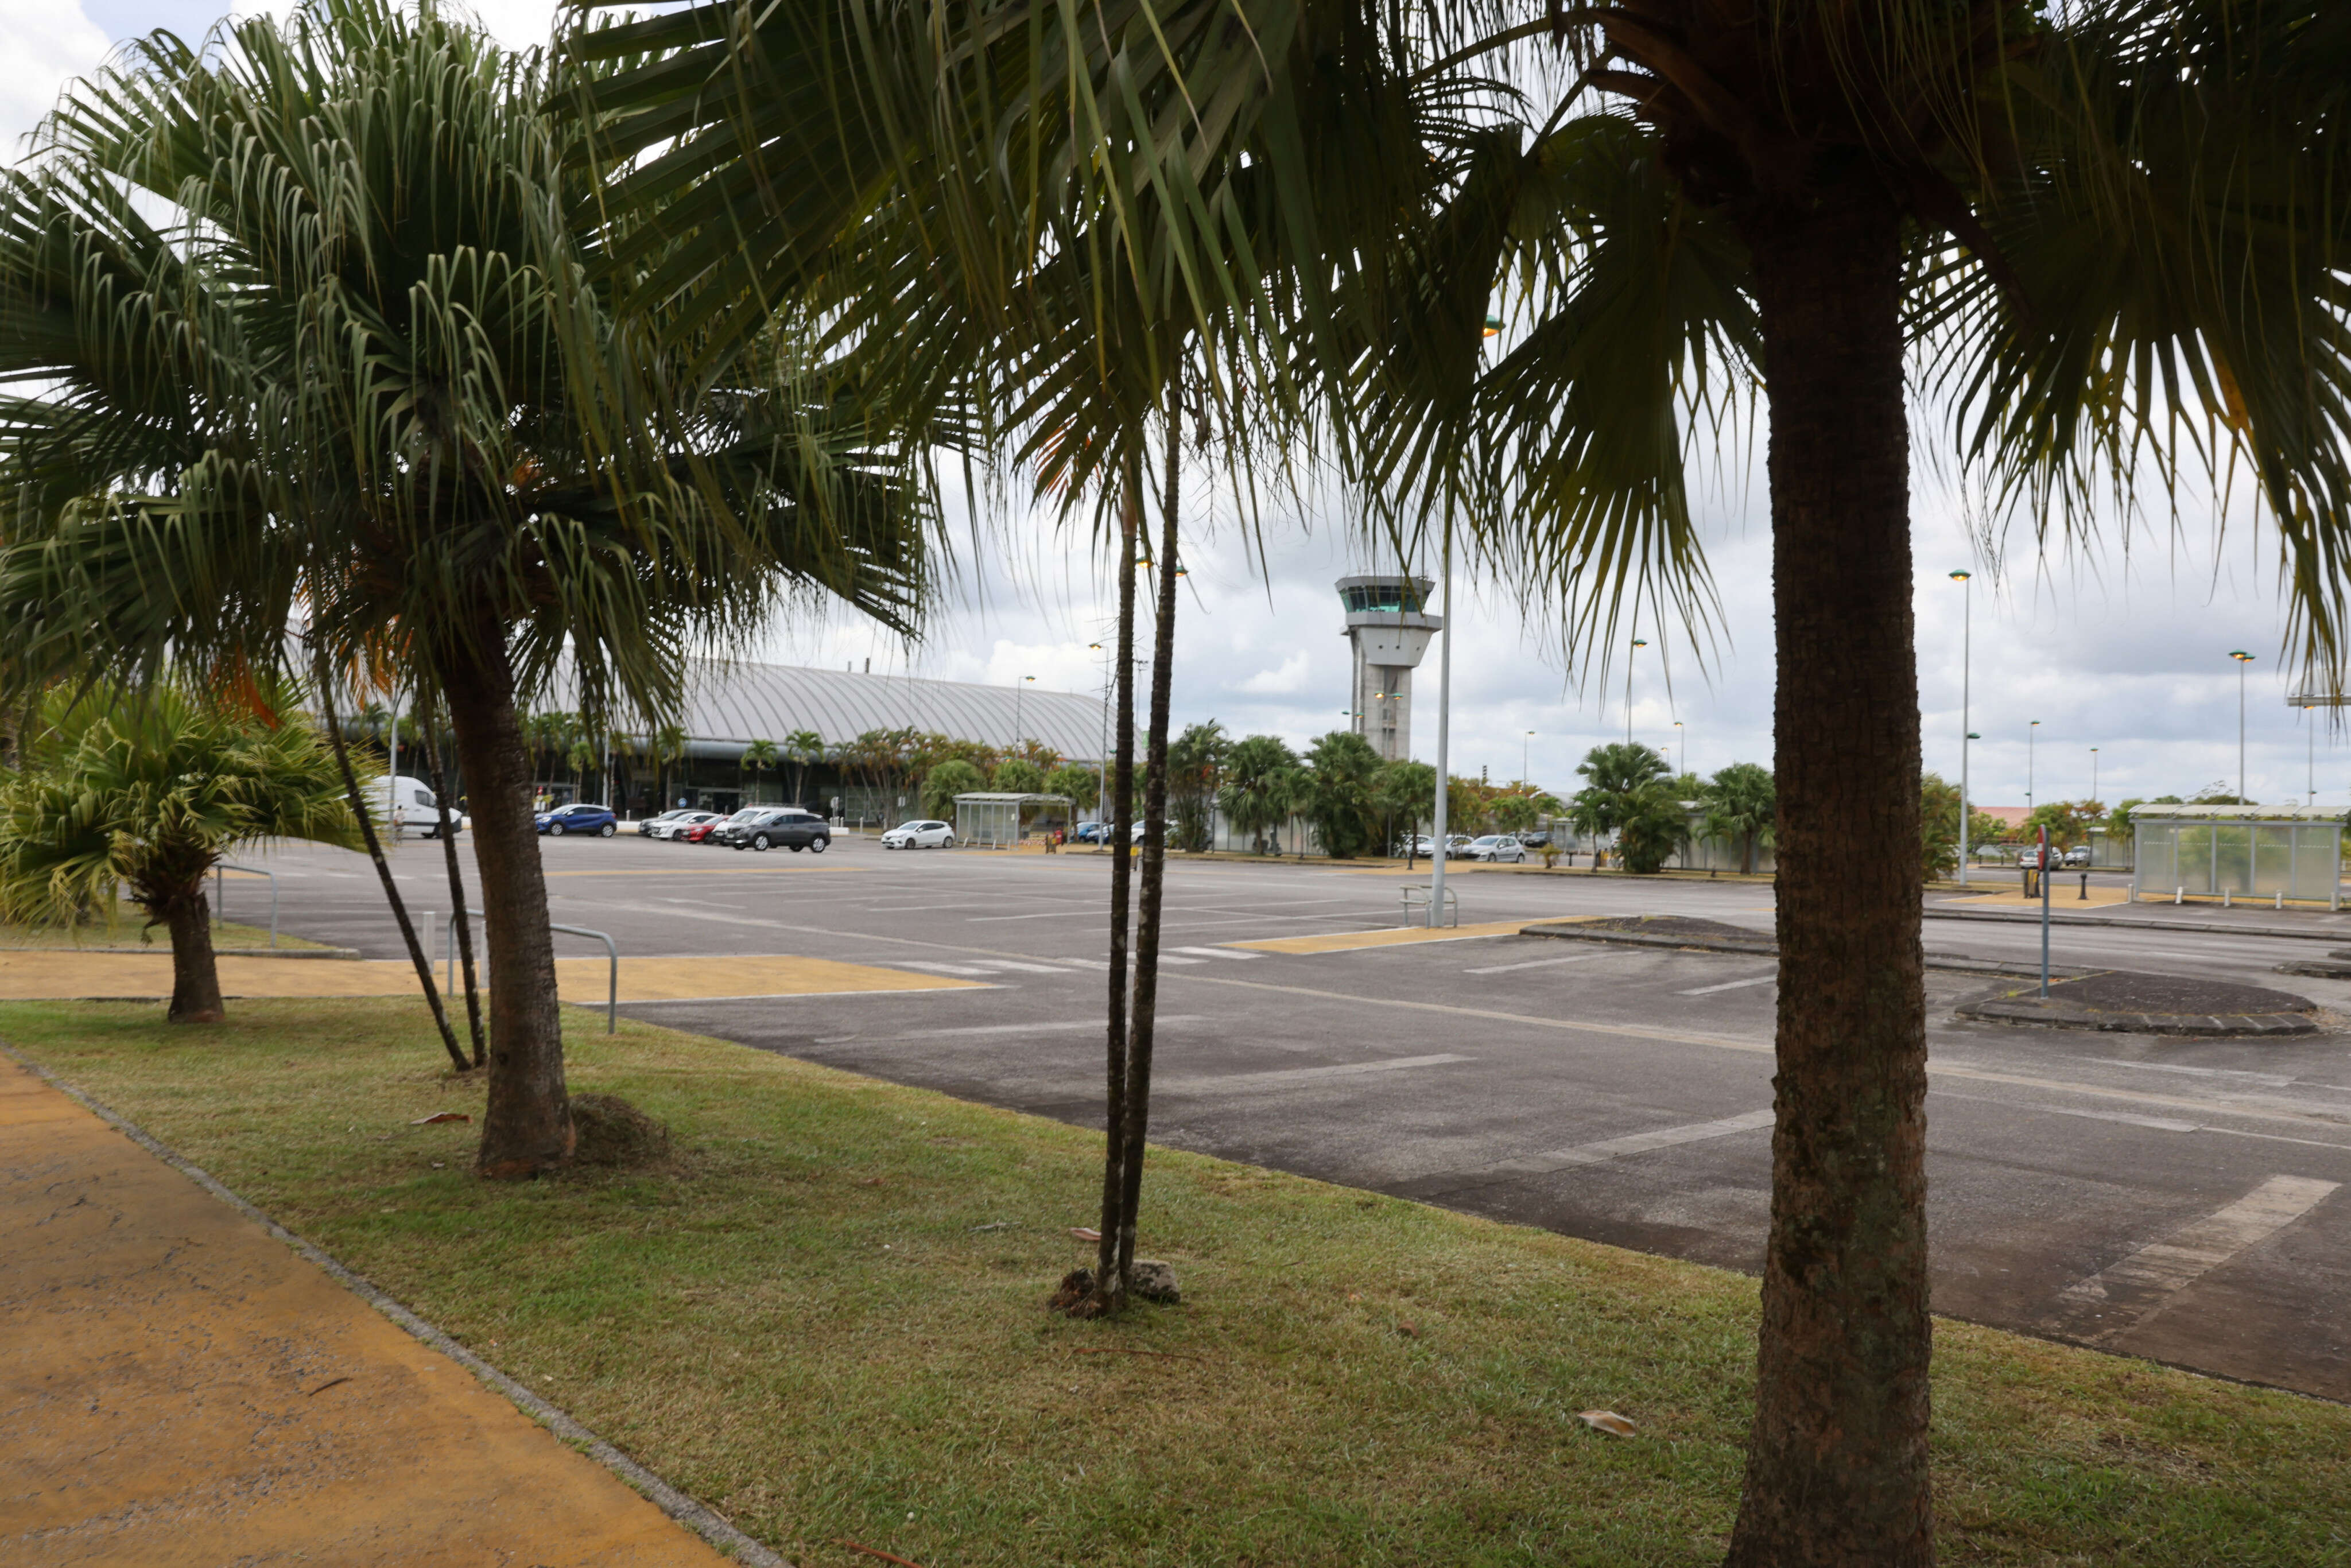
left=1728, top=178, right=1935, bottom=1568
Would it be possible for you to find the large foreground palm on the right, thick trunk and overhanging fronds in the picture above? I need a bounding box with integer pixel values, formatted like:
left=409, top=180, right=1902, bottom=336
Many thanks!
left=564, top=0, right=2351, bottom=1563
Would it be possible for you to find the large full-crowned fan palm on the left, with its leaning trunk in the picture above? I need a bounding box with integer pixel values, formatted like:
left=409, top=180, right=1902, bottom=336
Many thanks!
left=0, top=0, right=929, bottom=1175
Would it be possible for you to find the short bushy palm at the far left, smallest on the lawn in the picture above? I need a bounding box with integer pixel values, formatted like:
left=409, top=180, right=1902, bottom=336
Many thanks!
left=0, top=680, right=359, bottom=1024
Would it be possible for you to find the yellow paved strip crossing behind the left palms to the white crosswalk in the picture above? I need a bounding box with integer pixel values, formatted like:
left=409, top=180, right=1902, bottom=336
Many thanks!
left=0, top=952, right=978, bottom=1002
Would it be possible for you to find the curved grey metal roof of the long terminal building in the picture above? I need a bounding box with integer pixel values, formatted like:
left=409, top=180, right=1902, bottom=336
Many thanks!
left=576, top=658, right=1105, bottom=762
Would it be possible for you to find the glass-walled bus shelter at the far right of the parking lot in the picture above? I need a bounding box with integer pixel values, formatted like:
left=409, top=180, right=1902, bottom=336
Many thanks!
left=2130, top=806, right=2344, bottom=910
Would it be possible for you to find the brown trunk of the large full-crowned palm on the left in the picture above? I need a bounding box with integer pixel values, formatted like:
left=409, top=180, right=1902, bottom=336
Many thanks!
left=442, top=623, right=573, bottom=1180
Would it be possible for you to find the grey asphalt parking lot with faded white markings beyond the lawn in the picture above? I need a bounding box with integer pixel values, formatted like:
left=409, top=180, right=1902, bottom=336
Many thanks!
left=228, top=837, right=2351, bottom=1399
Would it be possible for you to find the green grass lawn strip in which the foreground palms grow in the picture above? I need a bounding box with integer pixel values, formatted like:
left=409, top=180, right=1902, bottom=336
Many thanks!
left=0, top=999, right=2351, bottom=1568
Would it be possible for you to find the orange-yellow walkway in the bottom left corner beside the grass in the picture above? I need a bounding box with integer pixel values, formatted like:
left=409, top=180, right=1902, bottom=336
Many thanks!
left=0, top=1062, right=727, bottom=1568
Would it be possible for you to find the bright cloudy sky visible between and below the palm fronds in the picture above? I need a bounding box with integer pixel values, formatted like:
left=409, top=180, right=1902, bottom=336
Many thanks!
left=14, top=0, right=2351, bottom=806
